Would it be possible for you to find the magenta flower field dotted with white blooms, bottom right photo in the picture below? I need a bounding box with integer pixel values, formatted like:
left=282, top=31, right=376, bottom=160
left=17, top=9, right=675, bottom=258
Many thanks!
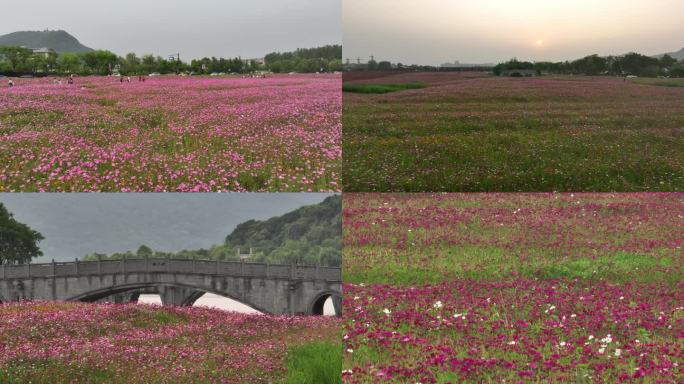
left=343, top=193, right=684, bottom=384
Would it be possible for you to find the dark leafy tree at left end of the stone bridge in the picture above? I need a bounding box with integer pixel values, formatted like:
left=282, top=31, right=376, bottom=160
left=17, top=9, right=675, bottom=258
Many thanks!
left=0, top=203, right=43, bottom=264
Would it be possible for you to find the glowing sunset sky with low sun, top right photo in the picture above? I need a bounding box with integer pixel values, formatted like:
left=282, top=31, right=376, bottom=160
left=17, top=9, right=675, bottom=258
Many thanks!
left=342, top=0, right=684, bottom=65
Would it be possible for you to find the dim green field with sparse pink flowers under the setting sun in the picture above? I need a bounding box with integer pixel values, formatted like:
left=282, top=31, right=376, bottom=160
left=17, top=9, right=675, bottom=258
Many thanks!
left=342, top=73, right=684, bottom=192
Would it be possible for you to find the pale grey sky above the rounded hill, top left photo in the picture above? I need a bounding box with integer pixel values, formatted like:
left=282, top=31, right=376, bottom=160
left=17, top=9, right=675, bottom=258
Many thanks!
left=0, top=0, right=342, bottom=60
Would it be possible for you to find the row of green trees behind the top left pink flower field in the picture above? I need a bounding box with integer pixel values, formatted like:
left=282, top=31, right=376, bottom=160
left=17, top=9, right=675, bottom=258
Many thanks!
left=0, top=45, right=342, bottom=76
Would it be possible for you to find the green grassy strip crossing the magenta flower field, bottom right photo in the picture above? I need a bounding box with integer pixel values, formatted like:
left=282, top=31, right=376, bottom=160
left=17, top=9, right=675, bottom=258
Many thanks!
left=343, top=246, right=684, bottom=286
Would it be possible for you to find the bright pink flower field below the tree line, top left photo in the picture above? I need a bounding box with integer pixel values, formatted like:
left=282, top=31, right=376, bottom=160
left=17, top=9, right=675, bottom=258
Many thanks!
left=0, top=75, right=342, bottom=192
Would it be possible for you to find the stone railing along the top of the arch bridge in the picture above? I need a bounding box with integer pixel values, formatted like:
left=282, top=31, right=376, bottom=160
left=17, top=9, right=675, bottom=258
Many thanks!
left=0, top=258, right=342, bottom=281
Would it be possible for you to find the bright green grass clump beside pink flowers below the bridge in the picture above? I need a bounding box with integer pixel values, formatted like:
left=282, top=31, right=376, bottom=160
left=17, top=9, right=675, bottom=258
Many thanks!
left=283, top=341, right=342, bottom=384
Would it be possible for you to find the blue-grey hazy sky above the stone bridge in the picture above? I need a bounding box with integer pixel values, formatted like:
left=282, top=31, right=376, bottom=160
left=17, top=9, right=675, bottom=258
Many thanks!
left=0, top=193, right=330, bottom=262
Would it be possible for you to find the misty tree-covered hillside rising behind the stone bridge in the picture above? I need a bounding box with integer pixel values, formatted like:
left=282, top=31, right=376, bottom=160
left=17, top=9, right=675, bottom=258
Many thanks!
left=85, top=195, right=342, bottom=266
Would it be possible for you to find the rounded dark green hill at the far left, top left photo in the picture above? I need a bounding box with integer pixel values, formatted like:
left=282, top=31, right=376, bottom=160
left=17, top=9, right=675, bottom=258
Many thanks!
left=0, top=30, right=93, bottom=53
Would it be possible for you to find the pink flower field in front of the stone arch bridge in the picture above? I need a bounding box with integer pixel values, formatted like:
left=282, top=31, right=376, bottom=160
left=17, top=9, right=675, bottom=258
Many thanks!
left=0, top=303, right=339, bottom=383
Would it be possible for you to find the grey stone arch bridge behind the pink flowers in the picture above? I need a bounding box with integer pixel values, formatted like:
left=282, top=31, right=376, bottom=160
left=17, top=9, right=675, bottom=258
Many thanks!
left=0, top=258, right=342, bottom=316
